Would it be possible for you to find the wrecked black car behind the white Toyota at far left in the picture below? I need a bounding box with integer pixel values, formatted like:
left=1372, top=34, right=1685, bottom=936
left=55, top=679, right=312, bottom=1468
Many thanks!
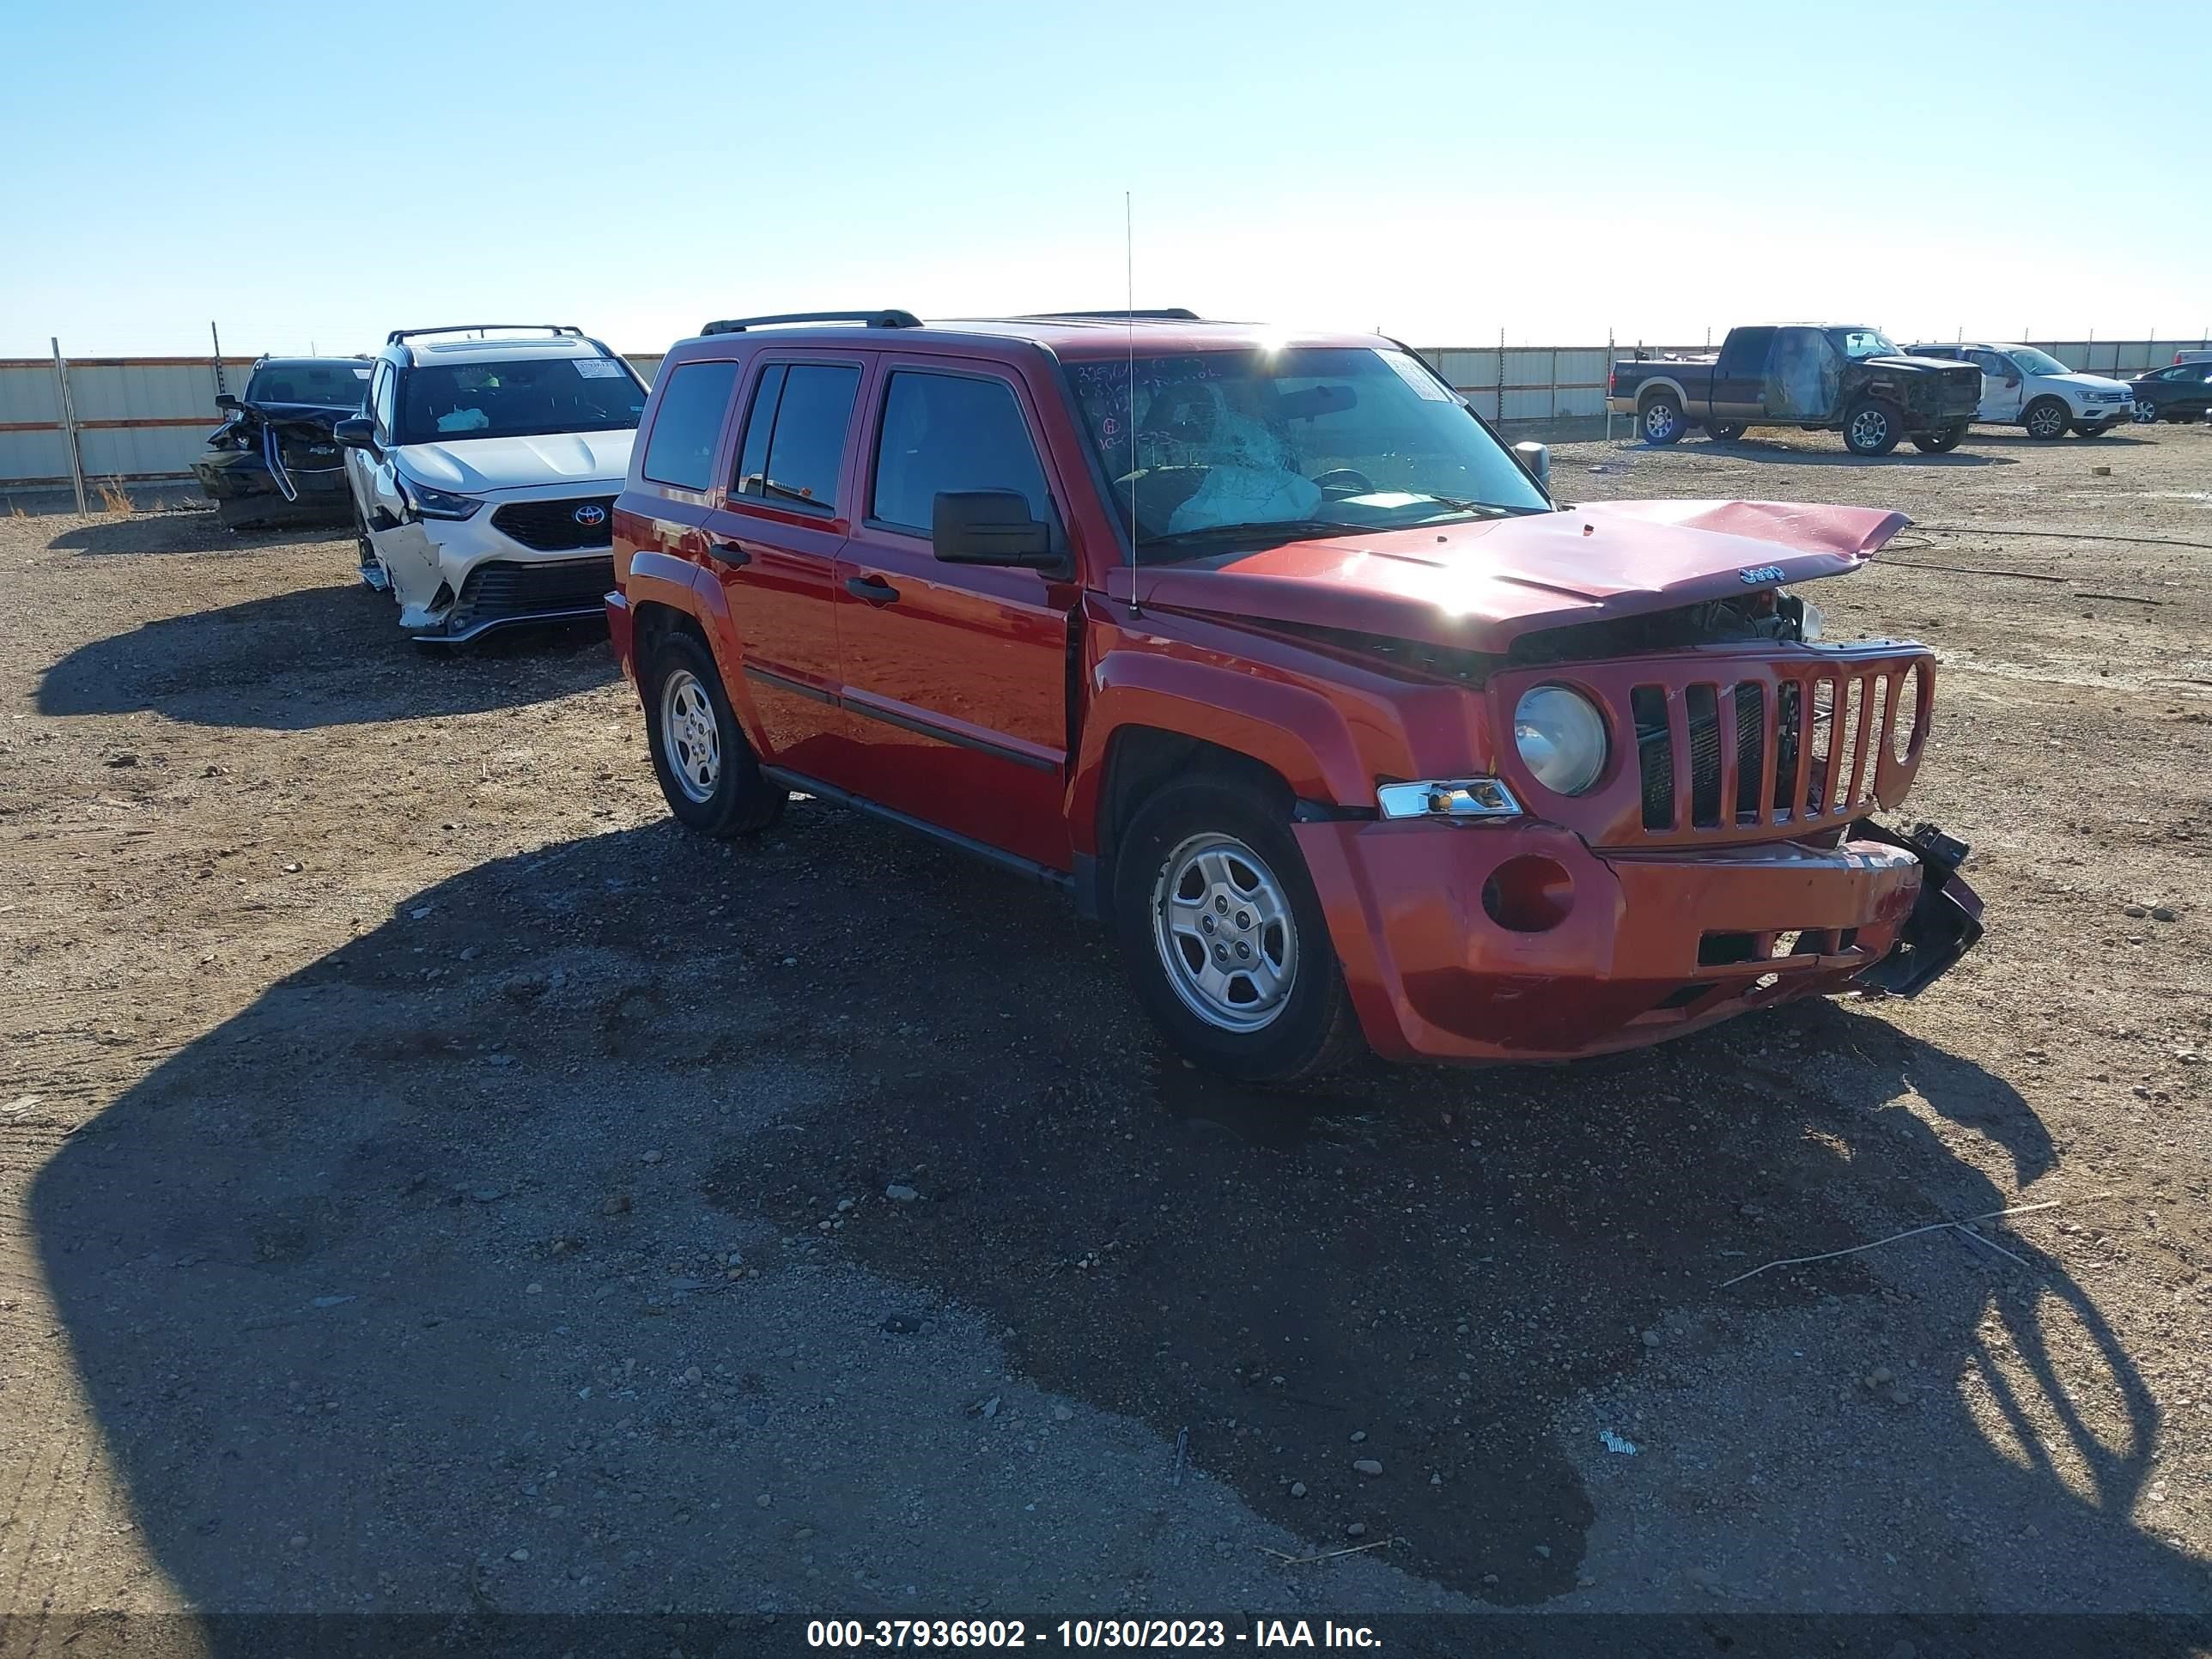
left=192, top=356, right=369, bottom=531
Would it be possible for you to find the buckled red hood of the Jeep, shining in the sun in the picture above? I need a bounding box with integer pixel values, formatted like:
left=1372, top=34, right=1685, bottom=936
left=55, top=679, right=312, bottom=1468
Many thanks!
left=1106, top=502, right=1911, bottom=653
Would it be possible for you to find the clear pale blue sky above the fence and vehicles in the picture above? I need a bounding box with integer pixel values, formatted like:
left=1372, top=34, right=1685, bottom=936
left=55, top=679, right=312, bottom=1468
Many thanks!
left=0, top=0, right=2212, bottom=356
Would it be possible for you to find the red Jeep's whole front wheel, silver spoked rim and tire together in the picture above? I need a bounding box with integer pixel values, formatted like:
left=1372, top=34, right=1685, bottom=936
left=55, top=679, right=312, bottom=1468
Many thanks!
left=1113, top=776, right=1358, bottom=1084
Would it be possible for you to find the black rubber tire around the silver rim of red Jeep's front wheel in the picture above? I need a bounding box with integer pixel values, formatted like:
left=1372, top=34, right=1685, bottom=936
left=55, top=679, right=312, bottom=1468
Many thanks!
left=1110, top=772, right=1360, bottom=1084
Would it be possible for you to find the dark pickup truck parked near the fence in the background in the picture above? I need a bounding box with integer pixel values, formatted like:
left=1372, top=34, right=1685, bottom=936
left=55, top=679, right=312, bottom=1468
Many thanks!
left=1606, top=323, right=1982, bottom=456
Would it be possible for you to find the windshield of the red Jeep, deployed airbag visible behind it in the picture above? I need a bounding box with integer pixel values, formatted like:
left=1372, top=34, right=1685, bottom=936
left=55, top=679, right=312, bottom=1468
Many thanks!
left=1068, top=345, right=1551, bottom=560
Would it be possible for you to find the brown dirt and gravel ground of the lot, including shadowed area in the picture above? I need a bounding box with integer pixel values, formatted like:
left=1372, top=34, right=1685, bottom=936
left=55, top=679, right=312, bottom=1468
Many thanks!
left=0, top=427, right=2212, bottom=1655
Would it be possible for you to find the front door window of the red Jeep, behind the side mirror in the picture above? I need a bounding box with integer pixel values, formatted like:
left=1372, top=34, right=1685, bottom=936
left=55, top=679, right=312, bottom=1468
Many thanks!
left=869, top=369, right=1051, bottom=535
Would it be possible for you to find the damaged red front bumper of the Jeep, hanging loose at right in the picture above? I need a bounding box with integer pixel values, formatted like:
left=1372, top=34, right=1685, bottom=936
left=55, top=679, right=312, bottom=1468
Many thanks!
left=1294, top=818, right=1982, bottom=1060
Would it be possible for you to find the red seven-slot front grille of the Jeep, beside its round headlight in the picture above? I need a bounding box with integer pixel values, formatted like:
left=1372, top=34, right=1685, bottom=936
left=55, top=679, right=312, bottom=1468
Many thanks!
left=1631, top=668, right=1917, bottom=832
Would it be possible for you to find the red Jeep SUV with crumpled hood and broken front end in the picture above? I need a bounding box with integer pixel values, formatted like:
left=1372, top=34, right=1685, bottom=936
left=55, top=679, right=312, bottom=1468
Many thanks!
left=606, top=312, right=1982, bottom=1079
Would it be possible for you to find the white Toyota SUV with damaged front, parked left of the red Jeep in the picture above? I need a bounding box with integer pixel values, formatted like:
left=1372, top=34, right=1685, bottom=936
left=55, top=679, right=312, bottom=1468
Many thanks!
left=337, top=323, right=646, bottom=644
